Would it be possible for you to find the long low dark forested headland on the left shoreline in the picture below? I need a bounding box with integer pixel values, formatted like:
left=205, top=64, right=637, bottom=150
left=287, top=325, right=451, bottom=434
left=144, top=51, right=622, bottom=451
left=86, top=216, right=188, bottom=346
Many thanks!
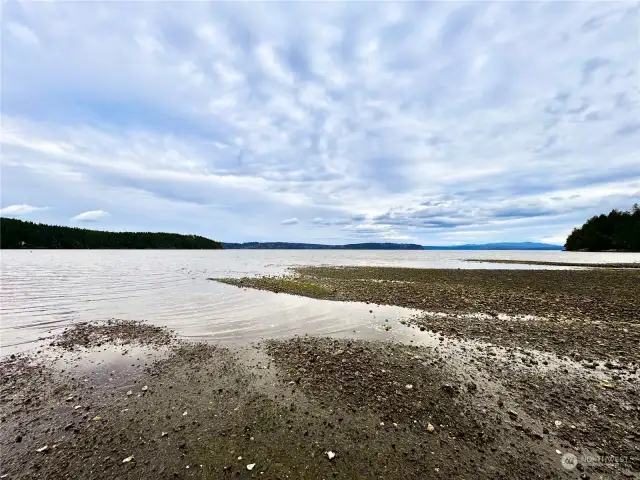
left=0, top=218, right=222, bottom=249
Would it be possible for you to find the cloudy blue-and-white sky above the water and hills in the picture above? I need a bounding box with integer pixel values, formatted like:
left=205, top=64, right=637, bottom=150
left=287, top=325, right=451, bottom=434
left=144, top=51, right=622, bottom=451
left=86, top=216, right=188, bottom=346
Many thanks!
left=0, top=1, right=640, bottom=244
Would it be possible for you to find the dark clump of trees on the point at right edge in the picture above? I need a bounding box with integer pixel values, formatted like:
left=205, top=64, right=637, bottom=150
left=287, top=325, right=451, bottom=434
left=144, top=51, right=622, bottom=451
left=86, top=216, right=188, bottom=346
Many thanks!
left=564, top=203, right=640, bottom=252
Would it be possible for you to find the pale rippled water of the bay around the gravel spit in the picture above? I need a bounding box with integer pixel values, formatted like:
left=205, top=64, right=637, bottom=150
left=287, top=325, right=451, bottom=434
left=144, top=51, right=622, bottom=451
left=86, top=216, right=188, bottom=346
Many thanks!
left=0, top=250, right=640, bottom=355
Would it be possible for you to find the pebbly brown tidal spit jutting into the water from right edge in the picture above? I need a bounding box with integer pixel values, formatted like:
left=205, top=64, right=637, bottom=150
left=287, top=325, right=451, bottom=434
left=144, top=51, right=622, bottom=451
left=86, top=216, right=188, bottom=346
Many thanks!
left=220, top=267, right=640, bottom=369
